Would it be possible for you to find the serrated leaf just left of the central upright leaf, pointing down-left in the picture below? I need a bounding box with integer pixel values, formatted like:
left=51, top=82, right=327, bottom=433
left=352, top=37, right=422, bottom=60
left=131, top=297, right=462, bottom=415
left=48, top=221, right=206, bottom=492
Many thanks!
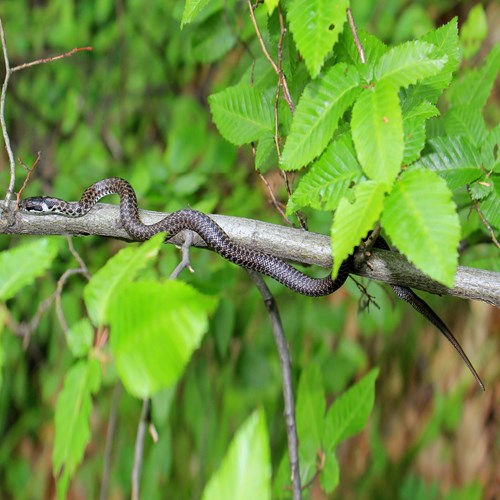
left=281, top=63, right=361, bottom=170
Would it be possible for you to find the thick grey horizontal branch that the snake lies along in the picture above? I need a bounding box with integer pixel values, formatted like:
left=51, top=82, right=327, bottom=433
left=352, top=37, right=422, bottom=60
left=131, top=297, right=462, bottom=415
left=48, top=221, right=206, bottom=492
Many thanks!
left=0, top=203, right=500, bottom=307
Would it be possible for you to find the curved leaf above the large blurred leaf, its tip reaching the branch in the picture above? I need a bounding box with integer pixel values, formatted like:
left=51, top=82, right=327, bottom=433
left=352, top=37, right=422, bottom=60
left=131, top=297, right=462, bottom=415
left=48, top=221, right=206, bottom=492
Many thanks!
left=83, top=234, right=165, bottom=326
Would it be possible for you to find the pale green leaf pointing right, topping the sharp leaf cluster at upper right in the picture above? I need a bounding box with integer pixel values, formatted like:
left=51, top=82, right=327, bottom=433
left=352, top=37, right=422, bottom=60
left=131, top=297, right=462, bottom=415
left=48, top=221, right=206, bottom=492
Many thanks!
left=374, top=41, right=448, bottom=87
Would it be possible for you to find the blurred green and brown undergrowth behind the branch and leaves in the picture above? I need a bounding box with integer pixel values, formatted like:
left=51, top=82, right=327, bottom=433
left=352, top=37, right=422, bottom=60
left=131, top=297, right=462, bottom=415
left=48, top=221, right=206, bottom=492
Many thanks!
left=0, top=0, right=500, bottom=499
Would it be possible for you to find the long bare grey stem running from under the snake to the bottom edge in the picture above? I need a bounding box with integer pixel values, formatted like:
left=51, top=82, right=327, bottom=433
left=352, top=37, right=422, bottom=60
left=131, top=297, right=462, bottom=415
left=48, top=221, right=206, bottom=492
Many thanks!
left=248, top=271, right=302, bottom=500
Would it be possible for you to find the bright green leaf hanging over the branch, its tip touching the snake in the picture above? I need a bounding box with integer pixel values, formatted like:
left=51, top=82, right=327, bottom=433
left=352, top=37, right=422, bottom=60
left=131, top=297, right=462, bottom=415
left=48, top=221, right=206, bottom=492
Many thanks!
left=331, top=181, right=386, bottom=277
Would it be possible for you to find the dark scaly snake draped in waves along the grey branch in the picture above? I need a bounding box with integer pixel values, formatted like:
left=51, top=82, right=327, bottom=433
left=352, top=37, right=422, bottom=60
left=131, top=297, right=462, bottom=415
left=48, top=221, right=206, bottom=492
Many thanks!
left=19, top=177, right=484, bottom=390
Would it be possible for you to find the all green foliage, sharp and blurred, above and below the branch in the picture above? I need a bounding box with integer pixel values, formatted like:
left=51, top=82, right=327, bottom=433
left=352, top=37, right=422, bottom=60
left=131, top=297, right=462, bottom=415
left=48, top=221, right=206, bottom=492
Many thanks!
left=0, top=0, right=500, bottom=498
